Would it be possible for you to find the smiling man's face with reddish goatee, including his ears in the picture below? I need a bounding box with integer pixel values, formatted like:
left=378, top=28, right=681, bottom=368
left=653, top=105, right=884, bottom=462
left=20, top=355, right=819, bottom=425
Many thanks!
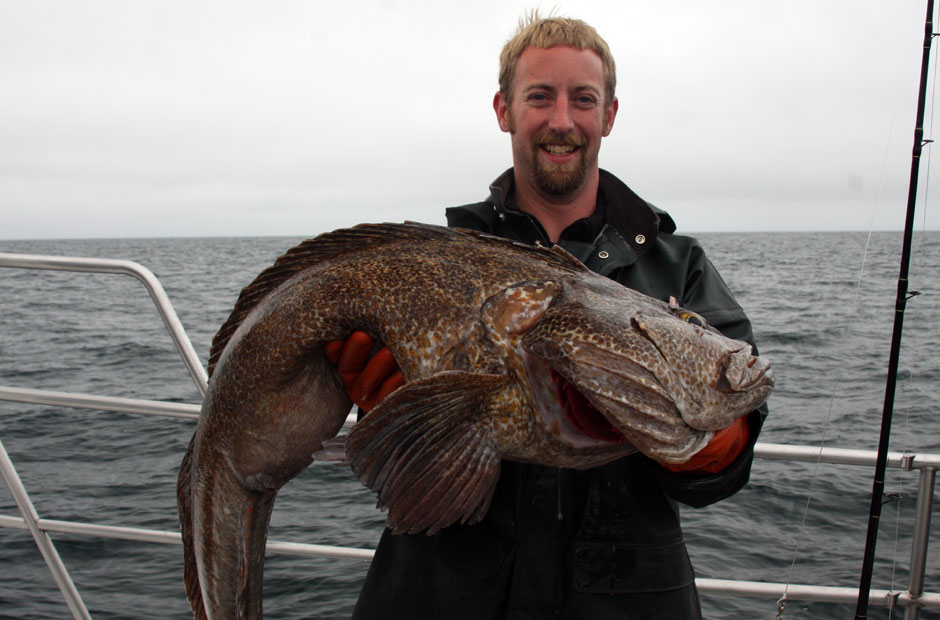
left=493, top=47, right=618, bottom=199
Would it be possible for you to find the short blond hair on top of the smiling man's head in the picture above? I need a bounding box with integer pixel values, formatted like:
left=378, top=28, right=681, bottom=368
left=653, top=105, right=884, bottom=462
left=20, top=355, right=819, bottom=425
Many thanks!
left=499, top=11, right=617, bottom=106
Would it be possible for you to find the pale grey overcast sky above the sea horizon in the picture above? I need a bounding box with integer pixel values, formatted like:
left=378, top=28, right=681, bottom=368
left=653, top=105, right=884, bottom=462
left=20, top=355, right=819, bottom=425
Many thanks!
left=0, top=0, right=940, bottom=239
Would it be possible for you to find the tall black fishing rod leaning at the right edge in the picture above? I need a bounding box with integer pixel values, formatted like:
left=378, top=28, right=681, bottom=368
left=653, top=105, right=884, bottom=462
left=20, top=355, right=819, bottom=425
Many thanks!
left=855, top=0, right=934, bottom=620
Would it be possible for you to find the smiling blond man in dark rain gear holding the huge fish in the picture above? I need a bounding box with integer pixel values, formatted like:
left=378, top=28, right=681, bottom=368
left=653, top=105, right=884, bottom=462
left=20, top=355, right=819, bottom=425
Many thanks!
left=329, top=16, right=763, bottom=620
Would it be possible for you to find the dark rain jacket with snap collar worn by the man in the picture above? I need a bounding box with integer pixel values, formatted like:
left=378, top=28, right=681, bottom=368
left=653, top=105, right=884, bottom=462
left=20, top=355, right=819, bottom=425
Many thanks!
left=353, top=169, right=766, bottom=620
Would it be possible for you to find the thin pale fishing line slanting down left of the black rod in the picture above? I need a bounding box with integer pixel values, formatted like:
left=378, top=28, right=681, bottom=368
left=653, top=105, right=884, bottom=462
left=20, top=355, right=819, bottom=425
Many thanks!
left=775, top=4, right=920, bottom=620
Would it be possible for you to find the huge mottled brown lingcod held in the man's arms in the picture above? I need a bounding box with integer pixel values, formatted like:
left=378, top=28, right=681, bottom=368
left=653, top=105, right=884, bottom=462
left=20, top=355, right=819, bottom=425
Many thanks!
left=178, top=224, right=773, bottom=618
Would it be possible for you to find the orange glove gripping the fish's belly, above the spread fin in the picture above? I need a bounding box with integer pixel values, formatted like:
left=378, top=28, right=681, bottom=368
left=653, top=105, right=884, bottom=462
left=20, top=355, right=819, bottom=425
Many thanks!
left=326, top=331, right=405, bottom=412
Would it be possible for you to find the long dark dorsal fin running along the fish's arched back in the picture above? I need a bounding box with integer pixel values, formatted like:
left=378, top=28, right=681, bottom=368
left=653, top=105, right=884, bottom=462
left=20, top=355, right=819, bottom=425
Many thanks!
left=208, top=222, right=584, bottom=377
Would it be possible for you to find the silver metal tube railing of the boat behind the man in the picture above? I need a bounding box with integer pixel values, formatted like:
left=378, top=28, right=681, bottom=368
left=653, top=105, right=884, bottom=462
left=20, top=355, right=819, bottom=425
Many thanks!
left=0, top=253, right=940, bottom=620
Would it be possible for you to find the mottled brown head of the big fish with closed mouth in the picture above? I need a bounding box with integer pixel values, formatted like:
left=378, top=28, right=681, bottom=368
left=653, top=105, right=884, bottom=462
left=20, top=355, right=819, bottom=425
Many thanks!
left=510, top=282, right=773, bottom=462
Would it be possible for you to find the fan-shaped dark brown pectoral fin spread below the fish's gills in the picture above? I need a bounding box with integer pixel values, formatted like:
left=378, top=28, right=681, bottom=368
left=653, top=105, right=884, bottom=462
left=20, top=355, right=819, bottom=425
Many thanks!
left=346, top=371, right=505, bottom=534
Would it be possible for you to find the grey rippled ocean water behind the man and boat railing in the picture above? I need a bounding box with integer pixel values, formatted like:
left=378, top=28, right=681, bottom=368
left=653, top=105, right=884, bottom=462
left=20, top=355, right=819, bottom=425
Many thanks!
left=0, top=232, right=940, bottom=619
